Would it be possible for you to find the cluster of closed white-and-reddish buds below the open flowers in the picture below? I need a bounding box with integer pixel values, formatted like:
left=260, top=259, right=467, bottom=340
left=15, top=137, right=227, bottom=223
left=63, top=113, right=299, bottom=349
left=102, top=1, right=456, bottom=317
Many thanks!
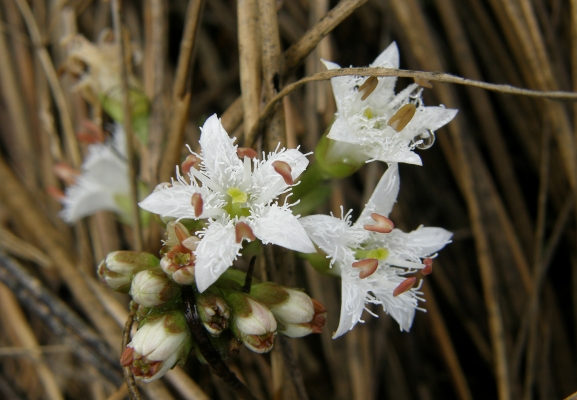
left=98, top=221, right=326, bottom=382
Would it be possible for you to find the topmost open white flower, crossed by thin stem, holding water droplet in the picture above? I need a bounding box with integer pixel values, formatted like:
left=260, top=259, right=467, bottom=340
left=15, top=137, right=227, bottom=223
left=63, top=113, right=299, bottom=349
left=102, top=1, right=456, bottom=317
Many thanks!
left=322, top=42, right=457, bottom=165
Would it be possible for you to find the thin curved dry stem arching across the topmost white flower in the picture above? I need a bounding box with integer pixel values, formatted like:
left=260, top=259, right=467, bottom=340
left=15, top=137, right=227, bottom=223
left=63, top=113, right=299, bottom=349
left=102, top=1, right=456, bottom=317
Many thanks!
left=244, top=67, right=577, bottom=146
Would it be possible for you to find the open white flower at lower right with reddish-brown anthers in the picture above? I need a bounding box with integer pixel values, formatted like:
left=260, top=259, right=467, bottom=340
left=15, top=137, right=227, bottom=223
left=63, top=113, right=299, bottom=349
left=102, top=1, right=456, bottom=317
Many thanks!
left=300, top=164, right=452, bottom=338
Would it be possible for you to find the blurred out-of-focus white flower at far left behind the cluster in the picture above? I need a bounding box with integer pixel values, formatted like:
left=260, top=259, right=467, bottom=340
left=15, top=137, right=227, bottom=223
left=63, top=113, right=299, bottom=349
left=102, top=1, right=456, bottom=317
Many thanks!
left=60, top=124, right=129, bottom=223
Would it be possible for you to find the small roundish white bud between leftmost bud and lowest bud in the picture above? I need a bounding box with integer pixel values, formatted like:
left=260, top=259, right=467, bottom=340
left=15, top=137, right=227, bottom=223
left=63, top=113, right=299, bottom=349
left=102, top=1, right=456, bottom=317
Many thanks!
left=130, top=268, right=180, bottom=307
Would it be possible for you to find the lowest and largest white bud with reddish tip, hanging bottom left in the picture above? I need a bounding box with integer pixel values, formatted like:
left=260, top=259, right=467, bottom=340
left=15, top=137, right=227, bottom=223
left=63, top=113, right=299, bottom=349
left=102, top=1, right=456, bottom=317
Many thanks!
left=120, top=311, right=192, bottom=382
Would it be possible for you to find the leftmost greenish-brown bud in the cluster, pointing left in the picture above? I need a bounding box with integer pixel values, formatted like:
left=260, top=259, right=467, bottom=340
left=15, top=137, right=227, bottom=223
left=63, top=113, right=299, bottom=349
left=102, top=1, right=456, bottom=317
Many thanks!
left=97, top=251, right=158, bottom=293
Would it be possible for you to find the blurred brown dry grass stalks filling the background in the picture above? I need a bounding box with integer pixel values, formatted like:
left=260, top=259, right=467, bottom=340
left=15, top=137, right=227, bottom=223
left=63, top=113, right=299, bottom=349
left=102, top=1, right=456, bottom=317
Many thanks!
left=0, top=0, right=577, bottom=400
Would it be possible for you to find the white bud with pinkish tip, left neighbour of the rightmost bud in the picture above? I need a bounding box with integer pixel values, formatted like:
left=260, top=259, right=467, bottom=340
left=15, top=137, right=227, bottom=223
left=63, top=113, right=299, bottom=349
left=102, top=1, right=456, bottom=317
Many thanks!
left=226, top=292, right=277, bottom=353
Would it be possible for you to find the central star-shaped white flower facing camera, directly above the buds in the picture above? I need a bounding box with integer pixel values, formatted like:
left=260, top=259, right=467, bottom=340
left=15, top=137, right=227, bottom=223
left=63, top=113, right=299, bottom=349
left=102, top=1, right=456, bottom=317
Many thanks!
left=140, top=115, right=315, bottom=292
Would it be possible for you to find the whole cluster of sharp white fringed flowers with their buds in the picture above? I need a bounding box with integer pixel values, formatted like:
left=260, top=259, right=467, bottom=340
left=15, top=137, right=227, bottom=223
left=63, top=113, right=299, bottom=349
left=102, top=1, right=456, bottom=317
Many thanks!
left=81, top=43, right=457, bottom=381
